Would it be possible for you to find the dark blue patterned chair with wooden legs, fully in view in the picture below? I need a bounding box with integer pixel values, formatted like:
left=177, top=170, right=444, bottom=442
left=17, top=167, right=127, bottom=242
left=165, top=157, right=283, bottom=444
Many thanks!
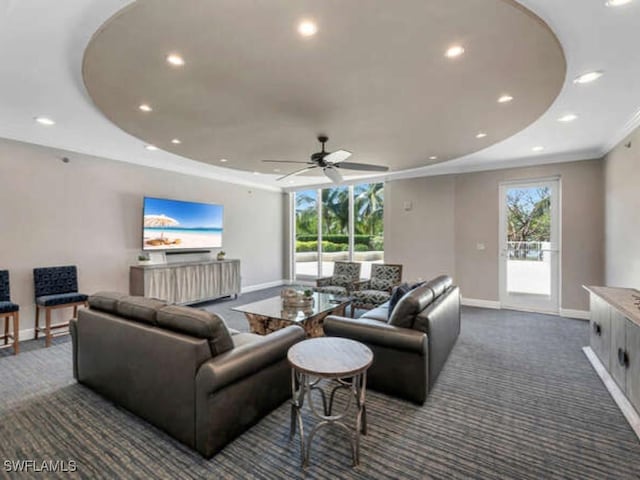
left=33, top=265, right=88, bottom=347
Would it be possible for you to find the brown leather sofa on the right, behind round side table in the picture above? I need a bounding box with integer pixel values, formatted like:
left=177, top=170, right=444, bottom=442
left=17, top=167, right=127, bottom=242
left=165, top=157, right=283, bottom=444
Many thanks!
left=324, top=275, right=460, bottom=404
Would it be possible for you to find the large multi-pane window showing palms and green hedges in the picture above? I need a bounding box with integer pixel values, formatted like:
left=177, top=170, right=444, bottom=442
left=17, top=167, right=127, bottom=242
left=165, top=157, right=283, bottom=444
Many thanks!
left=294, top=183, right=384, bottom=278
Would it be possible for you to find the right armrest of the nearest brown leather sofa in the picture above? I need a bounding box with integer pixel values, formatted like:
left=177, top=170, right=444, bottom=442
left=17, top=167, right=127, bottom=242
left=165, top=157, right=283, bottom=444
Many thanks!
left=196, top=325, right=305, bottom=395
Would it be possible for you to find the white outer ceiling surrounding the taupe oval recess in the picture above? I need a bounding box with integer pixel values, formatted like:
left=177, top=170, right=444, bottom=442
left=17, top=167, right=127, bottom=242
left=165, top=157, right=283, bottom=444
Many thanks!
left=0, top=0, right=640, bottom=192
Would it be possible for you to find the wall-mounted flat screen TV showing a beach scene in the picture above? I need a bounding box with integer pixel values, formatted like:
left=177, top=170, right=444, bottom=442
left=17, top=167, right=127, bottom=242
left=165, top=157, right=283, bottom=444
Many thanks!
left=142, top=197, right=223, bottom=250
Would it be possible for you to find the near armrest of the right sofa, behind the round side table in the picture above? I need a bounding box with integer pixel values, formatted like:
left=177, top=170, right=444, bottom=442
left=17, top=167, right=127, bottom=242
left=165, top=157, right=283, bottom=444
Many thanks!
left=323, top=315, right=428, bottom=355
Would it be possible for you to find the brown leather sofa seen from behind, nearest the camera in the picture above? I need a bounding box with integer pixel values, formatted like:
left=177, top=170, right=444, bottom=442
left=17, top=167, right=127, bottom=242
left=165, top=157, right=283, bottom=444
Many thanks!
left=70, top=292, right=305, bottom=458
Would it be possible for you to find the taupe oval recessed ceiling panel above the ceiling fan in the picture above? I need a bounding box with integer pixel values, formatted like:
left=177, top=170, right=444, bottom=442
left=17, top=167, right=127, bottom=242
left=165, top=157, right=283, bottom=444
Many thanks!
left=83, top=0, right=566, bottom=180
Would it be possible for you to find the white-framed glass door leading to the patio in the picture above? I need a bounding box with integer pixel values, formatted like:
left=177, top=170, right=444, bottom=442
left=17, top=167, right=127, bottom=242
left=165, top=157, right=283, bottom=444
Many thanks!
left=499, top=179, right=560, bottom=313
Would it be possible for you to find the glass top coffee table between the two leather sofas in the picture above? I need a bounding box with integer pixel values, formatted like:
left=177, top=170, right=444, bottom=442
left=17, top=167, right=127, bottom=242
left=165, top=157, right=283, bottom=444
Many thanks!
left=232, top=292, right=351, bottom=337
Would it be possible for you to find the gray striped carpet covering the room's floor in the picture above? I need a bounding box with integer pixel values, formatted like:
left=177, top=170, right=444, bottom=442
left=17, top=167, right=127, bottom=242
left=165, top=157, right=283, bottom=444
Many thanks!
left=0, top=290, right=640, bottom=480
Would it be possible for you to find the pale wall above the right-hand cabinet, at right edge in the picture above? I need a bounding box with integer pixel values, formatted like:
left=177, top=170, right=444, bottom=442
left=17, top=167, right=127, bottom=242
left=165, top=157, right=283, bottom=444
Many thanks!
left=605, top=125, right=640, bottom=289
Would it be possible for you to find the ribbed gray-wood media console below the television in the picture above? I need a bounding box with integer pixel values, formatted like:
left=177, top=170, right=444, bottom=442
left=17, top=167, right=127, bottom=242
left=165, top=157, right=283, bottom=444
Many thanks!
left=129, top=260, right=241, bottom=305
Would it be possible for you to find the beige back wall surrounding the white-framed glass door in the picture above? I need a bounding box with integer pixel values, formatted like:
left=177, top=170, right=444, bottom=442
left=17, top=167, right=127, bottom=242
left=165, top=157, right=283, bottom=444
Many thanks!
left=385, top=158, right=604, bottom=310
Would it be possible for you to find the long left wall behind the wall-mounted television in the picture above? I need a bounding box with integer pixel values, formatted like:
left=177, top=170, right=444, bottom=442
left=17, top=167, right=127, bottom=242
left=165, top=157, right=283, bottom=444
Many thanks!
left=0, top=140, right=286, bottom=336
